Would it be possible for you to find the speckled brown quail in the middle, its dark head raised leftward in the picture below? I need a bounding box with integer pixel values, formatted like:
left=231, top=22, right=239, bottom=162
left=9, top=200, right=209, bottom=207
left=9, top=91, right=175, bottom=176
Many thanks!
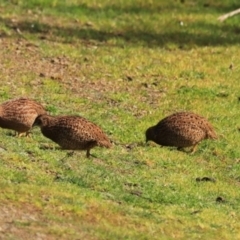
left=34, top=115, right=111, bottom=157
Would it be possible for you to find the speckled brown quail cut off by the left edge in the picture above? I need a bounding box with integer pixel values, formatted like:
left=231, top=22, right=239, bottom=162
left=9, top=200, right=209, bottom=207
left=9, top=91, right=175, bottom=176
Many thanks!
left=0, top=98, right=46, bottom=136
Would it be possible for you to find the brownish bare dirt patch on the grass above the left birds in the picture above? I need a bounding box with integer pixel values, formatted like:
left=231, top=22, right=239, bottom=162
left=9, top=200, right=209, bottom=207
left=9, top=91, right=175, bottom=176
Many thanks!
left=0, top=38, right=165, bottom=116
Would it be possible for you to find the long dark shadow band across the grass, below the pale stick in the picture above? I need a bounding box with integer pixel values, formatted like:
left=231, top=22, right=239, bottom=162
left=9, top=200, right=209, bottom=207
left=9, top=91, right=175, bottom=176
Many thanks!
left=0, top=6, right=240, bottom=49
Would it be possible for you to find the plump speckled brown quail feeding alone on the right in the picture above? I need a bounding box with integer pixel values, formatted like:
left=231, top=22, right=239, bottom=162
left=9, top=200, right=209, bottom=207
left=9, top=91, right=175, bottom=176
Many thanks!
left=146, top=112, right=217, bottom=152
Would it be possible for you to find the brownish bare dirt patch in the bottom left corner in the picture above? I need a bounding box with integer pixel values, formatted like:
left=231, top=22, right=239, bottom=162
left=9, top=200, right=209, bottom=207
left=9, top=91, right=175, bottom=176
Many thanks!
left=0, top=203, right=97, bottom=240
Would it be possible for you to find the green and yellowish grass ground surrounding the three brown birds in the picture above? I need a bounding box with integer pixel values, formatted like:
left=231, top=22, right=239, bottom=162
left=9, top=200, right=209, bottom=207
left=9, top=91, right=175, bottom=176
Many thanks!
left=0, top=0, right=240, bottom=240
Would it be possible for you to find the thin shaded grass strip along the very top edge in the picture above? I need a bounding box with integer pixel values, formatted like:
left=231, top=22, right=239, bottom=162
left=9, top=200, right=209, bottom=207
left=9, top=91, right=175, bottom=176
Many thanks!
left=9, top=0, right=240, bottom=17
